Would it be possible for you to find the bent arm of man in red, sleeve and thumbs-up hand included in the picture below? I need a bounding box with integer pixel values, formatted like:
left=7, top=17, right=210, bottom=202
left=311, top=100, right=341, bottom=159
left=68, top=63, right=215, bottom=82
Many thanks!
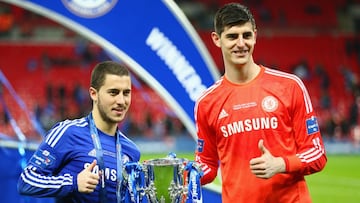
left=250, top=78, right=327, bottom=178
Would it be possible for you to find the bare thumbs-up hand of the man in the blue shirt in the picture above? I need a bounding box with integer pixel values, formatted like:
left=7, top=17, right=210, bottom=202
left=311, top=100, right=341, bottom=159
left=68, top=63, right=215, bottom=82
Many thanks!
left=77, top=160, right=100, bottom=193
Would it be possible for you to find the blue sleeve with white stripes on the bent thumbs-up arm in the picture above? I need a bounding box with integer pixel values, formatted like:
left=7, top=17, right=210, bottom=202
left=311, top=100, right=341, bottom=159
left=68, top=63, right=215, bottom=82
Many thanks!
left=18, top=123, right=77, bottom=197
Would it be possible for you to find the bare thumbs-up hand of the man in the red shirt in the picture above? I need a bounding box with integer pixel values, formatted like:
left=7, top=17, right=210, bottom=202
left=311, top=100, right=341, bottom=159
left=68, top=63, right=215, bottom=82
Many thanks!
left=250, top=139, right=285, bottom=179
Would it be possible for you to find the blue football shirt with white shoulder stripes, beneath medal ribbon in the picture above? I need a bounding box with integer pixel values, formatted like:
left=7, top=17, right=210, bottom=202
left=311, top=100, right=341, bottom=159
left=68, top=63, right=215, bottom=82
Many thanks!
left=18, top=117, right=140, bottom=203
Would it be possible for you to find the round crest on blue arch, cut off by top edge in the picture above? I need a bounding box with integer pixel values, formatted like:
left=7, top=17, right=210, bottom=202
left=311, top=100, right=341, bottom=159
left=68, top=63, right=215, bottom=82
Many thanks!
left=62, top=0, right=117, bottom=18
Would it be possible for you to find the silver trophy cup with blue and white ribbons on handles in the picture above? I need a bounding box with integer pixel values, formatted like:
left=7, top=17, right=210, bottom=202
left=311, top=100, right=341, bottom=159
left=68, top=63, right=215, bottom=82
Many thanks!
left=122, top=154, right=203, bottom=203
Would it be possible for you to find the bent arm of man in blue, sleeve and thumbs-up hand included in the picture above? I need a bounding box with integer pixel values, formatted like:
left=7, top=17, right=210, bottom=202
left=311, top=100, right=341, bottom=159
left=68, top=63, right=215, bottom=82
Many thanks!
left=18, top=121, right=98, bottom=197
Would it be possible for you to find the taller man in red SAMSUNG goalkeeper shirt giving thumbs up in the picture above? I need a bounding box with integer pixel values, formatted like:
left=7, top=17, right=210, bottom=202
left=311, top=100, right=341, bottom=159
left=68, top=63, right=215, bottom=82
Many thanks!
left=195, top=3, right=327, bottom=203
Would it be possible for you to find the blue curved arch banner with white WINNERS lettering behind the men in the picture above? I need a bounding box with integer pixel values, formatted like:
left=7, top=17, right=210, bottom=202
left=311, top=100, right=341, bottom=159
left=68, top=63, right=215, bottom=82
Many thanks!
left=3, top=0, right=219, bottom=138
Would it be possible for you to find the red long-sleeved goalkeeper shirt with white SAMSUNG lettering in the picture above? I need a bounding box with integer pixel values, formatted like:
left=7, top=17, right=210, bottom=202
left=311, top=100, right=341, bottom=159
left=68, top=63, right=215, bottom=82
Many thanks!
left=195, top=66, right=327, bottom=203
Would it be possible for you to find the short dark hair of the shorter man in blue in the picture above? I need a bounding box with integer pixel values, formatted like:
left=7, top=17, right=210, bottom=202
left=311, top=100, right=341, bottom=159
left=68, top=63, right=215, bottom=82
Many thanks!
left=90, top=61, right=130, bottom=90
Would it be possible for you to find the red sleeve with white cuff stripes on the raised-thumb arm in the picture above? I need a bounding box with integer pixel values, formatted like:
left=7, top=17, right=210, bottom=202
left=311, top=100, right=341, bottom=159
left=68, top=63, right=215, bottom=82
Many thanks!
left=284, top=76, right=327, bottom=175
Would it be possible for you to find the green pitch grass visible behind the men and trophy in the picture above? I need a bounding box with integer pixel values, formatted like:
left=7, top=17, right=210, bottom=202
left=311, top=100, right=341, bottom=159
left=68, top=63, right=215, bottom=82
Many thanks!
left=141, top=153, right=360, bottom=203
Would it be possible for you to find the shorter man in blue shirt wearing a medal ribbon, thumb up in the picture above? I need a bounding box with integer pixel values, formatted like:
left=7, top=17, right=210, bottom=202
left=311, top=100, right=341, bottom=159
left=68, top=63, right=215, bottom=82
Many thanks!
left=18, top=61, right=140, bottom=203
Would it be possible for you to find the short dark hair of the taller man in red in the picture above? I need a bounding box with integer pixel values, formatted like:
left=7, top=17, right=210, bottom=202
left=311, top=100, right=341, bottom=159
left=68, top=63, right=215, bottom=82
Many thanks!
left=214, top=3, right=256, bottom=35
